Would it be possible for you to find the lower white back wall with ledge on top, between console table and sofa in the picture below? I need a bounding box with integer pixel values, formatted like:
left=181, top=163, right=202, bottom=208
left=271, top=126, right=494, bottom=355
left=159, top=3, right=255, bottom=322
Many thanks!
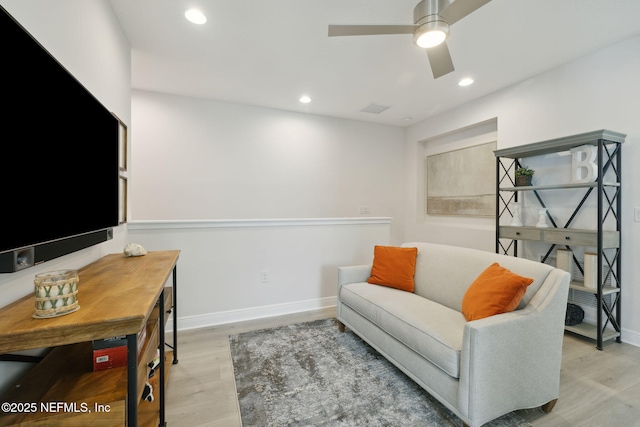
left=129, top=218, right=391, bottom=329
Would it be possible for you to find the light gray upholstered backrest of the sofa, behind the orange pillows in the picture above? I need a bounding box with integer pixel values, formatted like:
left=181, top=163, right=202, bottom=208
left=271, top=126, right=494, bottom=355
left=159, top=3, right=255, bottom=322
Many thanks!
left=402, top=242, right=553, bottom=311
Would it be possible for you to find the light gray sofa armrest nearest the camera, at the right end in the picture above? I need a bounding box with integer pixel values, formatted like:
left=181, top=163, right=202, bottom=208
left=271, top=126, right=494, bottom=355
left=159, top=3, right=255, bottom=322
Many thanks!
left=458, top=269, right=569, bottom=426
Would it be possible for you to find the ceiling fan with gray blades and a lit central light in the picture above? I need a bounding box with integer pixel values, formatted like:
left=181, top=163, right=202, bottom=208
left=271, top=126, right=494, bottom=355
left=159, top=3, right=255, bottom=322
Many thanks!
left=329, top=0, right=491, bottom=79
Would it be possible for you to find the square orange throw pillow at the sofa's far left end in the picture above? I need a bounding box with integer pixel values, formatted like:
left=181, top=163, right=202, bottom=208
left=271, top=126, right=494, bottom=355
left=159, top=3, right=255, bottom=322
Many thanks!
left=367, top=246, right=418, bottom=292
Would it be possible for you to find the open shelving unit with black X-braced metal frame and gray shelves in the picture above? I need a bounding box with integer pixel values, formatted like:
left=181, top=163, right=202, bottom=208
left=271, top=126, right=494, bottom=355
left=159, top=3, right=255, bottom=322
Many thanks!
left=495, top=130, right=626, bottom=350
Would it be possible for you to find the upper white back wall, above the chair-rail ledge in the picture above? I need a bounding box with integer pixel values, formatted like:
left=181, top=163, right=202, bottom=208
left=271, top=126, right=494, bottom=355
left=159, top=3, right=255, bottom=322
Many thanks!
left=131, top=91, right=404, bottom=241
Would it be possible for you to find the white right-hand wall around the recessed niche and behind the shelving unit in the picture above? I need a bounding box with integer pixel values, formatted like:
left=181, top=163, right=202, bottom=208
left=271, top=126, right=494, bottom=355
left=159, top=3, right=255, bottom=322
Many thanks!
left=405, top=37, right=640, bottom=345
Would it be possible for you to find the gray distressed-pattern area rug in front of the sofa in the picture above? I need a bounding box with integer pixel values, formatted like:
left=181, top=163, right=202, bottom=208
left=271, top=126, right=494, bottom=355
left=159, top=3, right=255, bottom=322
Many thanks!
left=229, top=319, right=530, bottom=427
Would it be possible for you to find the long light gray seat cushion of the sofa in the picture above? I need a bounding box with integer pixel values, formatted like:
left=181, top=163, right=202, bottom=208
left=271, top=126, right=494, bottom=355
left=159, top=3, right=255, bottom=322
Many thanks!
left=339, top=282, right=466, bottom=378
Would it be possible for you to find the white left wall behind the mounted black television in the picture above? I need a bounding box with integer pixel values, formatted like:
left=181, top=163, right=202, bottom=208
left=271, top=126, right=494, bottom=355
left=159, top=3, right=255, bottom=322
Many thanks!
left=0, top=0, right=131, bottom=394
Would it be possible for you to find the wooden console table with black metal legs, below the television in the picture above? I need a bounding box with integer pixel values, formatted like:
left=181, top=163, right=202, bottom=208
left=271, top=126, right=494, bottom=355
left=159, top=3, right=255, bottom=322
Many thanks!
left=0, top=251, right=180, bottom=427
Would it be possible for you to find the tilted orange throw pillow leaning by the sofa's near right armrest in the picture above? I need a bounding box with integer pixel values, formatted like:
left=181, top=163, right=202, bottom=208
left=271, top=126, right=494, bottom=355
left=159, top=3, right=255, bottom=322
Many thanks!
left=462, top=262, right=533, bottom=321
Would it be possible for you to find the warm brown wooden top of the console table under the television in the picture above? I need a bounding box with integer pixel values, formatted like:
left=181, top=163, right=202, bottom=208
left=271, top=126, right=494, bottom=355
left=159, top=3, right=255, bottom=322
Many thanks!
left=0, top=251, right=180, bottom=354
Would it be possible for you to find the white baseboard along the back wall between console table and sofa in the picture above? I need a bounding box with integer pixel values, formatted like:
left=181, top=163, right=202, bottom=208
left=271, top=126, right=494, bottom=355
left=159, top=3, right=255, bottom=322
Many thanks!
left=166, top=297, right=336, bottom=331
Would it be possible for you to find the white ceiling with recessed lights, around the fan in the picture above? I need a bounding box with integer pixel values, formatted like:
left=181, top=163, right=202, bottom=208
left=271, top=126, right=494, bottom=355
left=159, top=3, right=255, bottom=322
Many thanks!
left=110, top=0, right=640, bottom=126
